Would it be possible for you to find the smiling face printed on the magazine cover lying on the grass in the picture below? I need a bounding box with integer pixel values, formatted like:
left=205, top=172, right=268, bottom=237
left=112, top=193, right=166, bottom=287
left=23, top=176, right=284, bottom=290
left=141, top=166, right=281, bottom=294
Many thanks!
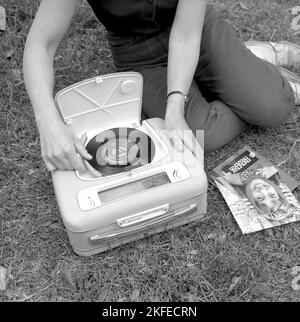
left=245, top=177, right=289, bottom=220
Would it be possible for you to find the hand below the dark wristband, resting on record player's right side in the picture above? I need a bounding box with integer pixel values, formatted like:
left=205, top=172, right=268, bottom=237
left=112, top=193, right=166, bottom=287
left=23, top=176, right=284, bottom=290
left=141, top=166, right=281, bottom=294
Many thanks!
left=165, top=97, right=202, bottom=157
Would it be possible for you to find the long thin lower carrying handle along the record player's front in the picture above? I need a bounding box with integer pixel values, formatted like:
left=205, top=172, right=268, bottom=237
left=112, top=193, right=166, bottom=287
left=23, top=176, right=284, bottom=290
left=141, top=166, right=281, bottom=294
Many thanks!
left=90, top=204, right=197, bottom=243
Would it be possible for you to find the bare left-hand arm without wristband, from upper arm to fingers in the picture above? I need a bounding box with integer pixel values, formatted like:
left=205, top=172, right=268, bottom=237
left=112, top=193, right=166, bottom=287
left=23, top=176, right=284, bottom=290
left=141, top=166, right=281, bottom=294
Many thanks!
left=23, top=0, right=90, bottom=170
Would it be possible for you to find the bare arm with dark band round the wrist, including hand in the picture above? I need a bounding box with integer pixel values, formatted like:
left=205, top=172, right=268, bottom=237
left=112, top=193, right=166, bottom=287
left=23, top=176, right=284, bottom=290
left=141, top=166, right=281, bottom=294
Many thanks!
left=166, top=0, right=207, bottom=155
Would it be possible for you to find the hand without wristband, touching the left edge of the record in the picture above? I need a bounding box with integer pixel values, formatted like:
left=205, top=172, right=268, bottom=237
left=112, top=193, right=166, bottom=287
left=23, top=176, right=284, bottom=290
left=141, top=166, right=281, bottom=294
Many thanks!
left=39, top=120, right=92, bottom=172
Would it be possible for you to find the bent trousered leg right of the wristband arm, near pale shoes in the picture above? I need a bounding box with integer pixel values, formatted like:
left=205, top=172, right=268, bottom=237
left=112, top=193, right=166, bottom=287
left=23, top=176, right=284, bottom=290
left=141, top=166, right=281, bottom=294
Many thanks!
left=195, top=8, right=295, bottom=127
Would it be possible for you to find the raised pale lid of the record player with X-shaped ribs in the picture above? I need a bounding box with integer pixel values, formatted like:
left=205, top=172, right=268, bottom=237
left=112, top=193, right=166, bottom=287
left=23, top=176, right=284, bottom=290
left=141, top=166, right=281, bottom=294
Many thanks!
left=55, top=72, right=143, bottom=136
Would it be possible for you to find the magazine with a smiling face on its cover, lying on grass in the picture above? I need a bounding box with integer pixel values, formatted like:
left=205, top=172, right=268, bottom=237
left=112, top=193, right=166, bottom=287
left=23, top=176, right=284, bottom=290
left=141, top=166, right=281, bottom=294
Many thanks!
left=211, top=147, right=300, bottom=234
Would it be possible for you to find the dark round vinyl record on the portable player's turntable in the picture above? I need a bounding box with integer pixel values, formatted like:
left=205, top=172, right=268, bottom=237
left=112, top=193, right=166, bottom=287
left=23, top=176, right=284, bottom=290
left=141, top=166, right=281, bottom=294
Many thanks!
left=86, top=127, right=155, bottom=176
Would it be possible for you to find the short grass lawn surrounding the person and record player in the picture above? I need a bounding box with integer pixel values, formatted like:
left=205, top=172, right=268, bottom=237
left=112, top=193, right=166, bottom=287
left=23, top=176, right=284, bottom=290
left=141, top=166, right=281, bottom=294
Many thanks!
left=0, top=0, right=300, bottom=302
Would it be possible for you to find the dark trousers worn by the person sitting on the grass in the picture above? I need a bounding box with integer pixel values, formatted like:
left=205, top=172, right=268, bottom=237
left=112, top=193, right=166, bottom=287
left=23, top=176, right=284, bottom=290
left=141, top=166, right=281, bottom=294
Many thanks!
left=108, top=6, right=294, bottom=151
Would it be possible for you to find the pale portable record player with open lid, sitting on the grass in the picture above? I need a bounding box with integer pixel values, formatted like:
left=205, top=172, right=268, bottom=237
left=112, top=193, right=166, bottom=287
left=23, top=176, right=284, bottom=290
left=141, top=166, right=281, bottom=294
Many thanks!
left=52, top=72, right=207, bottom=256
